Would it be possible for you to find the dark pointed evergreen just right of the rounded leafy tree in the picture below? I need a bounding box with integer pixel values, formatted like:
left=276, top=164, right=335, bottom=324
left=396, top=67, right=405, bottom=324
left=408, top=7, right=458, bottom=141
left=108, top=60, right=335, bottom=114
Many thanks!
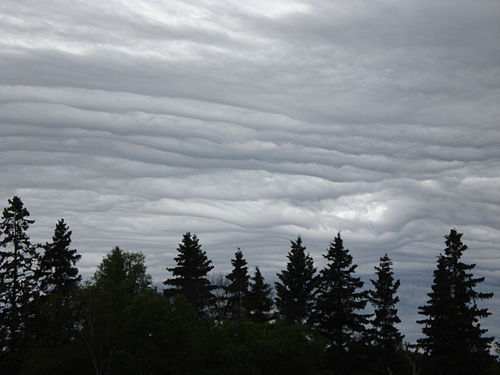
left=164, top=232, right=214, bottom=312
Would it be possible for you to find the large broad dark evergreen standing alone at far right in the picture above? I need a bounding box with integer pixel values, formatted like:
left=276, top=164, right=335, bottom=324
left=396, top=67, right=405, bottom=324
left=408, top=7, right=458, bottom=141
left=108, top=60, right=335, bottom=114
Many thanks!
left=418, top=229, right=493, bottom=375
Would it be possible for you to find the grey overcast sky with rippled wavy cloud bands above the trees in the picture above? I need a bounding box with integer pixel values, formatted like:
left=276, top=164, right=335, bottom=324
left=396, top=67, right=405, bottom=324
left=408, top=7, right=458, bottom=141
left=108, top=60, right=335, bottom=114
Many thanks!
left=0, top=0, right=500, bottom=341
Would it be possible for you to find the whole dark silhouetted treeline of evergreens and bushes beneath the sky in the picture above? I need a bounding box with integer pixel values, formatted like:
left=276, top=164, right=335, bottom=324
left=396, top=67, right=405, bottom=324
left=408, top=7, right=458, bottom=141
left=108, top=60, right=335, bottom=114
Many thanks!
left=0, top=197, right=500, bottom=375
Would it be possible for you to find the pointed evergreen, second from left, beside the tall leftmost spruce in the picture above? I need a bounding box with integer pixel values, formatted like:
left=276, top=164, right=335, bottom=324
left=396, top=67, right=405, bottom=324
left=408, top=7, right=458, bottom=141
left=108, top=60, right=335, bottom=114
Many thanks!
left=39, top=219, right=81, bottom=296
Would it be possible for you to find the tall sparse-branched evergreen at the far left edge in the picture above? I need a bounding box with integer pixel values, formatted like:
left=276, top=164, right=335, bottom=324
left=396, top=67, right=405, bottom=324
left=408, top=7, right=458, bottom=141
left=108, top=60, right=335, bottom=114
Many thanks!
left=0, top=196, right=38, bottom=362
